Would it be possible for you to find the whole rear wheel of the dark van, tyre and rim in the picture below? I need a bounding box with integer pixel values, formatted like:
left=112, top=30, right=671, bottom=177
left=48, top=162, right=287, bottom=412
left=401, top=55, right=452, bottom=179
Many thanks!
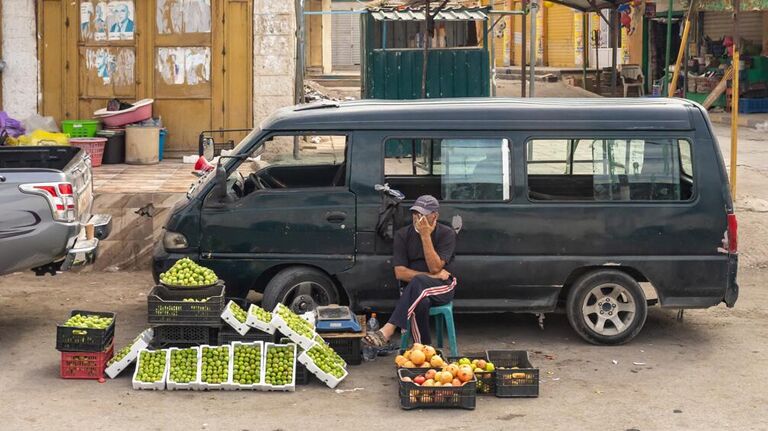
left=567, top=270, right=648, bottom=345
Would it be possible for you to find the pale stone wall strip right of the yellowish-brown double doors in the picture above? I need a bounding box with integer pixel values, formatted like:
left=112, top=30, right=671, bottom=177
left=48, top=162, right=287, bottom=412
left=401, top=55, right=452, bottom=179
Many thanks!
left=253, top=0, right=296, bottom=126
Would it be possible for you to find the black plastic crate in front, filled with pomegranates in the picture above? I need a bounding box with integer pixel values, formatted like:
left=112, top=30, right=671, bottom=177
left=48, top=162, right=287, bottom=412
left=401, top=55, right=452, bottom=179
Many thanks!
left=397, top=368, right=477, bottom=410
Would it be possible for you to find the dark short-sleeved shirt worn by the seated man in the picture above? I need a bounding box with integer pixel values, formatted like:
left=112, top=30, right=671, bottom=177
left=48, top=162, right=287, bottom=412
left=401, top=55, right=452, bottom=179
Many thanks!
left=392, top=223, right=456, bottom=273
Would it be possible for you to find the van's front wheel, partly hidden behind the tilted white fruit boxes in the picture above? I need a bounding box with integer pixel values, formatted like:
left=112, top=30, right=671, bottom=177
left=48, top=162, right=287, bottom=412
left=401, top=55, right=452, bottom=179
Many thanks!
left=262, top=267, right=339, bottom=314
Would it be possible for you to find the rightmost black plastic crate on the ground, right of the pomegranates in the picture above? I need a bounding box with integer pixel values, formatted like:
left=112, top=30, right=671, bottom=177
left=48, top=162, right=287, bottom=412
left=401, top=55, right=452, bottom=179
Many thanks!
left=486, top=350, right=539, bottom=398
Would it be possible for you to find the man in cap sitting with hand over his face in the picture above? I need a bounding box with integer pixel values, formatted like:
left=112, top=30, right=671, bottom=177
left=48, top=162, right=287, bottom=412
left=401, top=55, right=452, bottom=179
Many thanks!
left=365, top=195, right=456, bottom=347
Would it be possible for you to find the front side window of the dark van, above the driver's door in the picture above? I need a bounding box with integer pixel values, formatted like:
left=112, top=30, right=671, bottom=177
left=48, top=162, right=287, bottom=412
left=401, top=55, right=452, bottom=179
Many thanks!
left=237, top=134, right=347, bottom=195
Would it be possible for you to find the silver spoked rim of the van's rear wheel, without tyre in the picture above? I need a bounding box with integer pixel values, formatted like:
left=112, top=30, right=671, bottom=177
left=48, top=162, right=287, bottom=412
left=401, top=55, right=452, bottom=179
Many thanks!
left=581, top=283, right=637, bottom=336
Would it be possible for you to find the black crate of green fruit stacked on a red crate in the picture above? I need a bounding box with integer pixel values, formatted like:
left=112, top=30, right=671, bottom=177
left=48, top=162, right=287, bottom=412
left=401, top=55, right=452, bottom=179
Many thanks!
left=56, top=310, right=115, bottom=380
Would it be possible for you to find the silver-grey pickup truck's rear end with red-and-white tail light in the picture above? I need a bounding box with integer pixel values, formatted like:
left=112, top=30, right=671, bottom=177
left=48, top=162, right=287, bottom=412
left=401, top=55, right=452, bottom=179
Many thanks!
left=0, top=146, right=112, bottom=275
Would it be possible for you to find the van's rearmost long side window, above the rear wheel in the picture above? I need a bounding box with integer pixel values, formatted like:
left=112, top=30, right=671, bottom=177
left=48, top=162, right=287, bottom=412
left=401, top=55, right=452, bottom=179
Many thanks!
left=526, top=138, right=693, bottom=201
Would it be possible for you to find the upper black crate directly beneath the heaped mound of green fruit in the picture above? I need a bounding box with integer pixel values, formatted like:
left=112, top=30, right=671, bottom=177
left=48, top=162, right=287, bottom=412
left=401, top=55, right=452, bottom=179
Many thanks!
left=147, top=284, right=225, bottom=325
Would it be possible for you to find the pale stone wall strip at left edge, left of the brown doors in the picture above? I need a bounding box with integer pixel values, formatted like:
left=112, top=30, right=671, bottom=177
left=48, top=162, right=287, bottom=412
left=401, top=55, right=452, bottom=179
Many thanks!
left=0, top=0, right=40, bottom=120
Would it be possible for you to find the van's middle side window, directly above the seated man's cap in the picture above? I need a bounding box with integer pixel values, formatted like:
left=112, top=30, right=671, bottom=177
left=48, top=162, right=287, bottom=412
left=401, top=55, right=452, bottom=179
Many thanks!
left=384, top=138, right=511, bottom=201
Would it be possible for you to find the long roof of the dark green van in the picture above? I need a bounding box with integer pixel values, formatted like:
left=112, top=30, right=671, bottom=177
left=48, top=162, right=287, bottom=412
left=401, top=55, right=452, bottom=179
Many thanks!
left=261, top=98, right=697, bottom=131
